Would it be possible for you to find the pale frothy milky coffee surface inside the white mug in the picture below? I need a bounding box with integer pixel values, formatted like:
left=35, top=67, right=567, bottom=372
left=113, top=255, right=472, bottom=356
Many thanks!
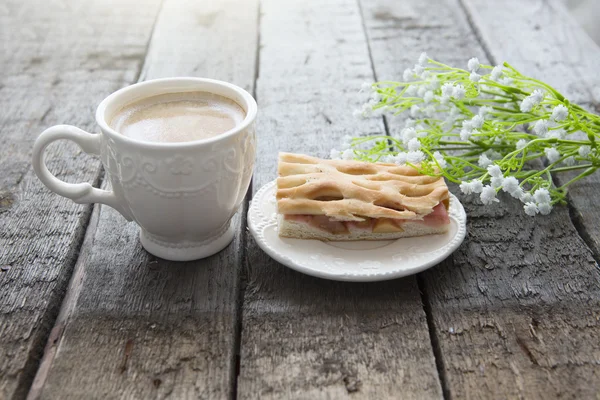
left=110, top=92, right=246, bottom=143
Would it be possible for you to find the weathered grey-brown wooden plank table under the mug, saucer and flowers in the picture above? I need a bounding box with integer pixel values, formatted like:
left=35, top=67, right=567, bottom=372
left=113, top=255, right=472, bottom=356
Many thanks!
left=0, top=0, right=600, bottom=399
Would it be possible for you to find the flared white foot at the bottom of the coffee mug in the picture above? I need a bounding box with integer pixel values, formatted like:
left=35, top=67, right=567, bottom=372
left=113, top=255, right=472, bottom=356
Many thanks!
left=140, top=223, right=235, bottom=261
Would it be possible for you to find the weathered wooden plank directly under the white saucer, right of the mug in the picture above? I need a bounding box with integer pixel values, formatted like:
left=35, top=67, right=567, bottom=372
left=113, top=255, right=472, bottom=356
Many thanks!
left=238, top=0, right=441, bottom=399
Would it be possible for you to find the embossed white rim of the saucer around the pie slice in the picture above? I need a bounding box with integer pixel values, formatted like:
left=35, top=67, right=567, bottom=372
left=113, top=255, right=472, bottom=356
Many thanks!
left=248, top=180, right=466, bottom=282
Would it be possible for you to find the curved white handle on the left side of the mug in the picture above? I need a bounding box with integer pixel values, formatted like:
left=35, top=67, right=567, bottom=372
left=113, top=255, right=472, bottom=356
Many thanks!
left=33, top=125, right=132, bottom=221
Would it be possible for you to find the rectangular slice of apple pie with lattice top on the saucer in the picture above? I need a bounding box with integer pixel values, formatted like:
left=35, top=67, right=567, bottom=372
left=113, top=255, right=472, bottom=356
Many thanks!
left=277, top=153, right=450, bottom=240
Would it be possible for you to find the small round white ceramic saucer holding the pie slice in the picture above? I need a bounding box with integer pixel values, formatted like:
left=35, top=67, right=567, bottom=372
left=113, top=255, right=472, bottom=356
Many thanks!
left=248, top=181, right=467, bottom=282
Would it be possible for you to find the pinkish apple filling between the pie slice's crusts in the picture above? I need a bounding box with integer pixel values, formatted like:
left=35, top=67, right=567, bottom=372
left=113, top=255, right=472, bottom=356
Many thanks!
left=284, top=202, right=450, bottom=234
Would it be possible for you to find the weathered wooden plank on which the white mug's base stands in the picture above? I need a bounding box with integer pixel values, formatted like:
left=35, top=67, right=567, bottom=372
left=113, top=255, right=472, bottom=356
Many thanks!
left=30, top=0, right=258, bottom=399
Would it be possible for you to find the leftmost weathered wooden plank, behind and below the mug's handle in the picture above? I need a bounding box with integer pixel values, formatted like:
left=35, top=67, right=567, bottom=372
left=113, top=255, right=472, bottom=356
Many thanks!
left=0, top=0, right=163, bottom=399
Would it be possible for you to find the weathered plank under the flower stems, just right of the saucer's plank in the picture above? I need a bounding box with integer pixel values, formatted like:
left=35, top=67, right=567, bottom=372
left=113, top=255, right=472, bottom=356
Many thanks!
left=364, top=0, right=600, bottom=399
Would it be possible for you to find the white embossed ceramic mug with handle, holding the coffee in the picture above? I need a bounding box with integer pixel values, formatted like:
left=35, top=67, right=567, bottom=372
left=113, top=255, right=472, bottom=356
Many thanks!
left=33, top=78, right=257, bottom=261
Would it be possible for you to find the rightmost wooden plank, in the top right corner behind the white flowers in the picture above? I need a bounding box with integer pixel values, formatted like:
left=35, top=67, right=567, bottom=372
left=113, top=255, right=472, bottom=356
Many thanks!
left=465, top=0, right=600, bottom=260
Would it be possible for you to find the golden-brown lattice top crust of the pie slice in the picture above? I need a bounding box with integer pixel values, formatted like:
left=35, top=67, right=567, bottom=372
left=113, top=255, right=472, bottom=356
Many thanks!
left=277, top=153, right=449, bottom=221
